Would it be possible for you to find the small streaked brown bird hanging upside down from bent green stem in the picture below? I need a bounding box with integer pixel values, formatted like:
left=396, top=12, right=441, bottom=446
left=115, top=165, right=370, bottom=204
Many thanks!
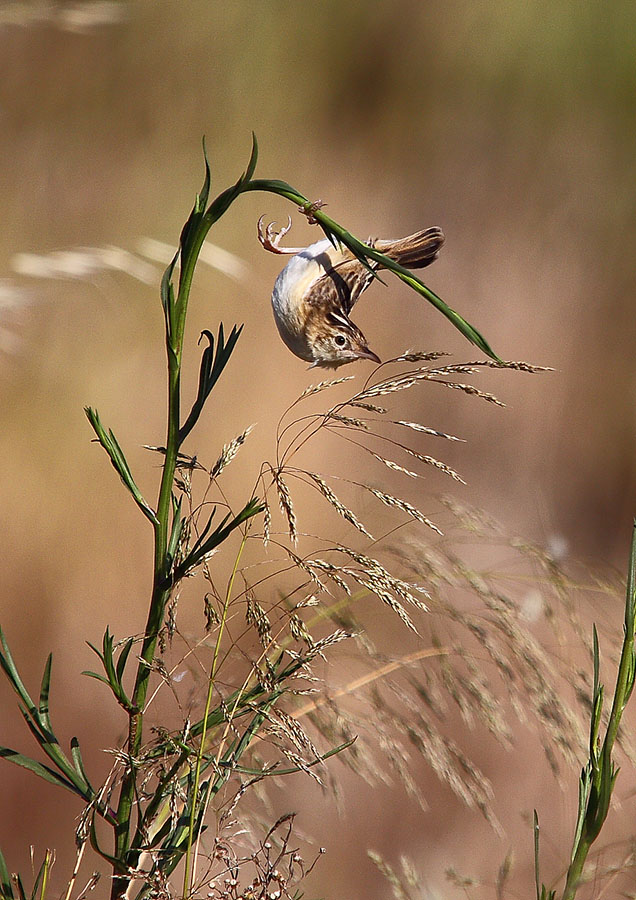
left=258, top=216, right=444, bottom=368
